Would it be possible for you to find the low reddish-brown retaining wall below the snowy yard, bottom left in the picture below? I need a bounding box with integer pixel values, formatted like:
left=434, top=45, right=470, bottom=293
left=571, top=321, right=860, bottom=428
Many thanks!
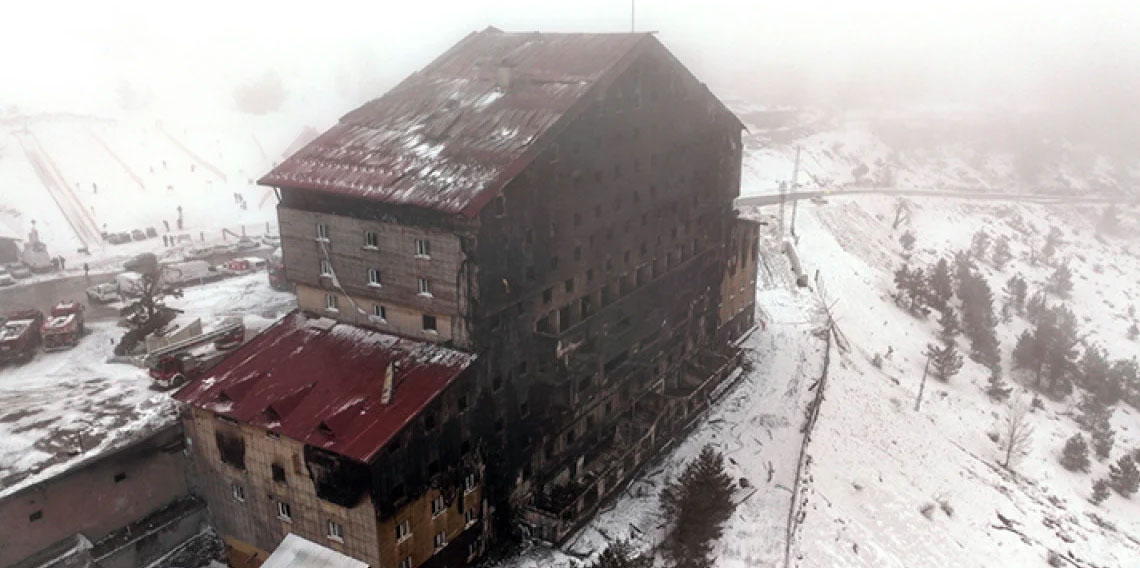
left=0, top=424, right=188, bottom=566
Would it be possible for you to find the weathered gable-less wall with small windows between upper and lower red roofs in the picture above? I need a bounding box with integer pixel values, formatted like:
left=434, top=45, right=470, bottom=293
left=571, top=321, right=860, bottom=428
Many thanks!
left=277, top=204, right=467, bottom=346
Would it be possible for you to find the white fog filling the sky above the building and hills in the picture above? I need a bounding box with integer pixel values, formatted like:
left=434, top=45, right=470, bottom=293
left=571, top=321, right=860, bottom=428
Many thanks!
left=0, top=0, right=1140, bottom=148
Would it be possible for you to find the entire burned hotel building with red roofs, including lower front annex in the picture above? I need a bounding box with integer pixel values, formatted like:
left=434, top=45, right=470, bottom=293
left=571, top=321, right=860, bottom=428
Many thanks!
left=178, top=29, right=757, bottom=568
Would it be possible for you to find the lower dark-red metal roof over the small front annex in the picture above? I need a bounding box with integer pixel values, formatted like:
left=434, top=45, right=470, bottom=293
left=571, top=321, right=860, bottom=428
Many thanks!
left=174, top=311, right=474, bottom=462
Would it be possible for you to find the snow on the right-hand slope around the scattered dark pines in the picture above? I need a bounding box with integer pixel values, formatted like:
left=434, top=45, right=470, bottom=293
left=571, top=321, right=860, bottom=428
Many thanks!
left=797, top=193, right=1140, bottom=567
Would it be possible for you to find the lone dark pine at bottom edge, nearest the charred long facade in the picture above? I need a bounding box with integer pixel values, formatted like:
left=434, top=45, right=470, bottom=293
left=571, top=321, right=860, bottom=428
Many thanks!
left=661, top=446, right=735, bottom=568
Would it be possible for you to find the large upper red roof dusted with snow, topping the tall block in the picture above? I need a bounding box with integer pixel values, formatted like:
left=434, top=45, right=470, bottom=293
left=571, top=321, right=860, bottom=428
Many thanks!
left=259, top=27, right=650, bottom=220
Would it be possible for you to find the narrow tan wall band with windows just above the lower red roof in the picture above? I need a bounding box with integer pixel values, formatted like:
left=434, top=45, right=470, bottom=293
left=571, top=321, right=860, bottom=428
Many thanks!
left=296, top=284, right=464, bottom=342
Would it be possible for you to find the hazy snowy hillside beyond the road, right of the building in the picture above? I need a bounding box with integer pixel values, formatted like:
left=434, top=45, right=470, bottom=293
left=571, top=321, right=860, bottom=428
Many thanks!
left=730, top=103, right=1140, bottom=195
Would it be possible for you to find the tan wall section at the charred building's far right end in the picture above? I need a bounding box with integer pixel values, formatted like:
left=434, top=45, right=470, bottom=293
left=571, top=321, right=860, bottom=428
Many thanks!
left=717, top=219, right=759, bottom=338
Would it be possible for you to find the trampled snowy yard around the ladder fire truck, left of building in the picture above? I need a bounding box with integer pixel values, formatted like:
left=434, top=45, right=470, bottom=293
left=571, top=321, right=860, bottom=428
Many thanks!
left=0, top=273, right=295, bottom=495
